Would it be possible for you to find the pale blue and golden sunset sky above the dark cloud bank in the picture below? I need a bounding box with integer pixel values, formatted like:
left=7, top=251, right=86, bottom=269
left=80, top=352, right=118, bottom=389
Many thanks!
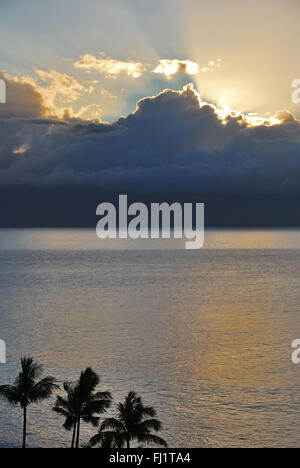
left=0, top=0, right=300, bottom=121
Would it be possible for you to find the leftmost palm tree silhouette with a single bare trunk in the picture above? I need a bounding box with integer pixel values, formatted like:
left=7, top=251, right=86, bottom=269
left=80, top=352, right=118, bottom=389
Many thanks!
left=0, top=357, right=58, bottom=448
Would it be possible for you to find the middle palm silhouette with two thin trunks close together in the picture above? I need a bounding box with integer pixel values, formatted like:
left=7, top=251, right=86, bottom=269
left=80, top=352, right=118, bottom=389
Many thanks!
left=53, top=367, right=112, bottom=448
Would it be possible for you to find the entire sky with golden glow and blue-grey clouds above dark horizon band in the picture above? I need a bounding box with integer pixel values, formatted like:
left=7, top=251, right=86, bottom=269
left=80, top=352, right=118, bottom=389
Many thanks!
left=0, top=0, right=300, bottom=227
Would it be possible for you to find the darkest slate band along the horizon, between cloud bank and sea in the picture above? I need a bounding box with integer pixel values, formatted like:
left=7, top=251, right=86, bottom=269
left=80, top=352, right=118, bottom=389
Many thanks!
left=0, top=187, right=300, bottom=228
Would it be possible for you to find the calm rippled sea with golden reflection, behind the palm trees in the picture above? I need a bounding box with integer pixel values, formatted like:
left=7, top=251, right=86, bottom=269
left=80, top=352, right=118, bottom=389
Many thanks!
left=0, top=230, right=300, bottom=447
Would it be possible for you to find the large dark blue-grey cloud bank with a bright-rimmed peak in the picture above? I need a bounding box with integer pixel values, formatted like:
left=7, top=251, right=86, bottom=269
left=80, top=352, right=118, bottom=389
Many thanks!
left=0, top=84, right=300, bottom=195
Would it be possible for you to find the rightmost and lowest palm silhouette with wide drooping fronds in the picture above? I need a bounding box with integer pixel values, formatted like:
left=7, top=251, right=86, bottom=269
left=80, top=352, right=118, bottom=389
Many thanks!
left=90, top=392, right=167, bottom=448
